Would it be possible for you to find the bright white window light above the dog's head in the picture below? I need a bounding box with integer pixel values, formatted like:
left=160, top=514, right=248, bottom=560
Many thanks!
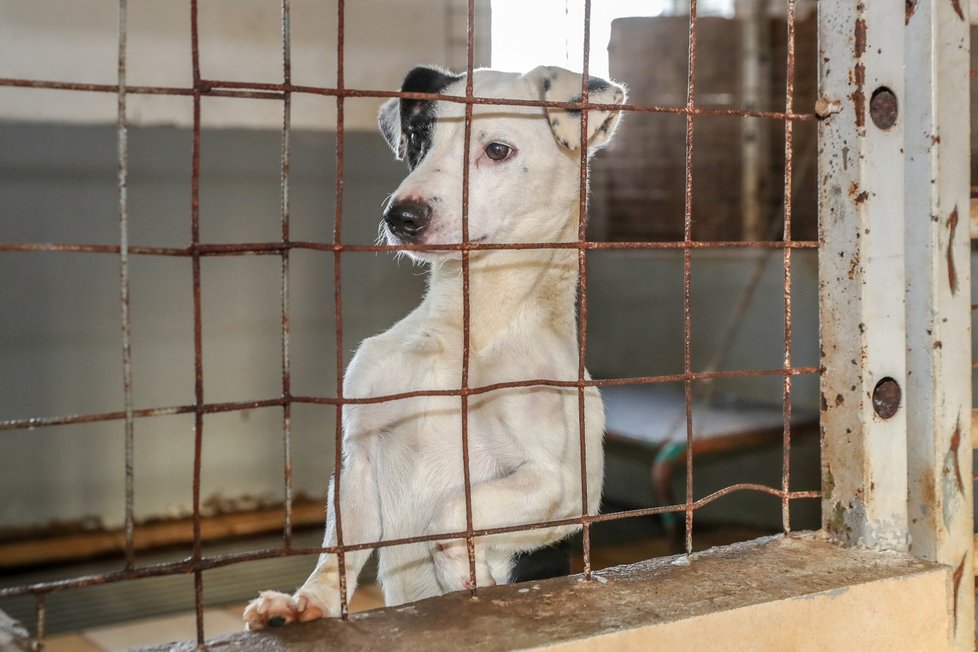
left=492, top=0, right=668, bottom=77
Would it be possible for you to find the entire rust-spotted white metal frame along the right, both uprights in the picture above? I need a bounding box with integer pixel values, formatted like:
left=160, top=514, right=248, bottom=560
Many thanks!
left=818, top=0, right=975, bottom=650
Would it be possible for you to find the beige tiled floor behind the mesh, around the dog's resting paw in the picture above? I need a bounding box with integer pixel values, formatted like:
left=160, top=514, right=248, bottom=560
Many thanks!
left=44, top=585, right=384, bottom=652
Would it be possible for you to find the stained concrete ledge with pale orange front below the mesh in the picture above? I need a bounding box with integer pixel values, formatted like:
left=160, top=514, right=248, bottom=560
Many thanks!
left=141, top=533, right=952, bottom=652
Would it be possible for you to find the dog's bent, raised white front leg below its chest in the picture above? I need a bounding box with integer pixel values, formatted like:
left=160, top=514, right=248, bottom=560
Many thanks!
left=431, top=463, right=580, bottom=592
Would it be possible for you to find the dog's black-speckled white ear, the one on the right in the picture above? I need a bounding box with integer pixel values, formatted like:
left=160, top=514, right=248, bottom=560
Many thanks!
left=526, top=66, right=625, bottom=155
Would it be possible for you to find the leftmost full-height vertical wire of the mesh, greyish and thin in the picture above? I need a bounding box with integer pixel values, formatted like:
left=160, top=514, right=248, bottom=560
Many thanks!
left=116, top=0, right=136, bottom=568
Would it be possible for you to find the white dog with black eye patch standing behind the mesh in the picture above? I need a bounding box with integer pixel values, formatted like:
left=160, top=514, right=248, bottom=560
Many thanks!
left=244, top=67, right=625, bottom=629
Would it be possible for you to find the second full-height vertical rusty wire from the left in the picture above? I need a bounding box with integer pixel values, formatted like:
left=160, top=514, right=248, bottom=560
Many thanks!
left=190, top=0, right=204, bottom=645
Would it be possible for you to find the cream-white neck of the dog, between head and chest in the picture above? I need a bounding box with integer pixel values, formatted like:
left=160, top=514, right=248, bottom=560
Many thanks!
left=425, top=204, right=580, bottom=356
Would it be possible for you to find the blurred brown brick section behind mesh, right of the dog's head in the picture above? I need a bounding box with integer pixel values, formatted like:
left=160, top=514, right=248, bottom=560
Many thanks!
left=592, top=16, right=817, bottom=241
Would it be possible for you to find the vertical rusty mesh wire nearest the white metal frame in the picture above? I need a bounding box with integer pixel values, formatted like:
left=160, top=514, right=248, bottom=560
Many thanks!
left=781, top=0, right=795, bottom=532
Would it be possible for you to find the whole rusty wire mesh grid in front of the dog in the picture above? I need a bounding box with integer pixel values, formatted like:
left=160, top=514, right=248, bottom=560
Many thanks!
left=0, top=0, right=820, bottom=643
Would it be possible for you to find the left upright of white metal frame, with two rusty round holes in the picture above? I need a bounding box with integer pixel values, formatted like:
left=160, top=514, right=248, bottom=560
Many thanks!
left=818, top=0, right=907, bottom=550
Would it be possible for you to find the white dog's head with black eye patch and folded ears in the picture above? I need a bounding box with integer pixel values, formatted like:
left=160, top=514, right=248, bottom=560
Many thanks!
left=379, top=67, right=625, bottom=260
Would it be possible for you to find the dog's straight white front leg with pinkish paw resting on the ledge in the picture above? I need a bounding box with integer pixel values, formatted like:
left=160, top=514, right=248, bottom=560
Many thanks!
left=242, top=444, right=381, bottom=629
